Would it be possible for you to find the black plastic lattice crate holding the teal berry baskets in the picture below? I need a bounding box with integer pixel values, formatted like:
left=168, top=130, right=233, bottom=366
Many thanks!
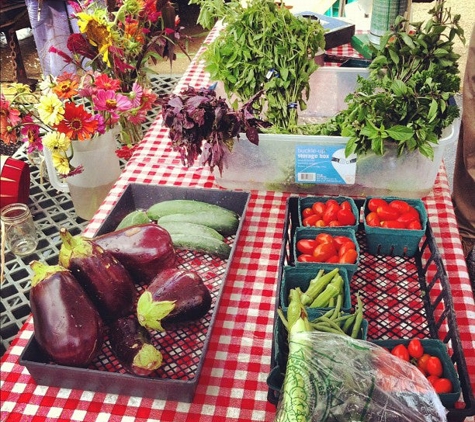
left=268, top=197, right=475, bottom=421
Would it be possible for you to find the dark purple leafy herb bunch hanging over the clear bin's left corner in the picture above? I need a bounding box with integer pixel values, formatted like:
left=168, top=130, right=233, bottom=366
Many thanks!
left=160, top=87, right=269, bottom=174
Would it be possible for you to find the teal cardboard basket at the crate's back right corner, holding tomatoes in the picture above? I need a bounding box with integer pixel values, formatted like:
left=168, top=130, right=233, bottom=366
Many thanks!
left=363, top=196, right=427, bottom=257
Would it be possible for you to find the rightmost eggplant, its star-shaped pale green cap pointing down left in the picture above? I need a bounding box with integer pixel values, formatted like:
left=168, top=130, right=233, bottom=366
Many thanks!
left=137, top=268, right=211, bottom=331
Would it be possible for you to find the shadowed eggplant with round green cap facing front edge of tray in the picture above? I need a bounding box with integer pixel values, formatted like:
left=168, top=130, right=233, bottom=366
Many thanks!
left=109, top=315, right=163, bottom=377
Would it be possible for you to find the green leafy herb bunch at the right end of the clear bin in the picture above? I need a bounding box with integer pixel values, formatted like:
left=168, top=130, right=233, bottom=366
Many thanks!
left=301, top=2, right=465, bottom=159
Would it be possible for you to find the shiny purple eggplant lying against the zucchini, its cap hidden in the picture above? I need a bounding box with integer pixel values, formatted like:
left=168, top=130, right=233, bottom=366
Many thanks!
left=93, top=223, right=176, bottom=284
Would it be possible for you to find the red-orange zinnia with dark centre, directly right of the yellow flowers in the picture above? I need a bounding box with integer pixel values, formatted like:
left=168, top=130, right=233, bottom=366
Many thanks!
left=56, top=103, right=99, bottom=141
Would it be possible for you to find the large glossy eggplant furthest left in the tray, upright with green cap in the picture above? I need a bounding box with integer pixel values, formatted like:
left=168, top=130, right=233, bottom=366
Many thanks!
left=30, top=261, right=104, bottom=367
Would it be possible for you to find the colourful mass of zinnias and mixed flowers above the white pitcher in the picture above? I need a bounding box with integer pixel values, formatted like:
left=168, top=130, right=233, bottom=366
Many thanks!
left=0, top=0, right=184, bottom=177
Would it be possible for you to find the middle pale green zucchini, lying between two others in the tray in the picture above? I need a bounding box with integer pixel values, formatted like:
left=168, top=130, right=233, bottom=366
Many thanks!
left=157, top=211, right=239, bottom=236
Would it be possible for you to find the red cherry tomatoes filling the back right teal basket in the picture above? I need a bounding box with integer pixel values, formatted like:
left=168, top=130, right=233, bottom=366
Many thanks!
left=365, top=198, right=422, bottom=230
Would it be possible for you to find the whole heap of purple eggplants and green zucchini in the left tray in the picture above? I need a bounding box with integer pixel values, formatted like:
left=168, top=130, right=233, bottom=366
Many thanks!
left=27, top=200, right=240, bottom=377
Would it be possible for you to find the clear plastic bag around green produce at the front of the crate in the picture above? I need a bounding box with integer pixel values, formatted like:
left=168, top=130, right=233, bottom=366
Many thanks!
left=276, top=332, right=447, bottom=422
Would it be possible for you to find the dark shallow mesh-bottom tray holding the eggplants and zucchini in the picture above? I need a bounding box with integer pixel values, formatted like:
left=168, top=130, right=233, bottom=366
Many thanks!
left=20, top=184, right=253, bottom=402
